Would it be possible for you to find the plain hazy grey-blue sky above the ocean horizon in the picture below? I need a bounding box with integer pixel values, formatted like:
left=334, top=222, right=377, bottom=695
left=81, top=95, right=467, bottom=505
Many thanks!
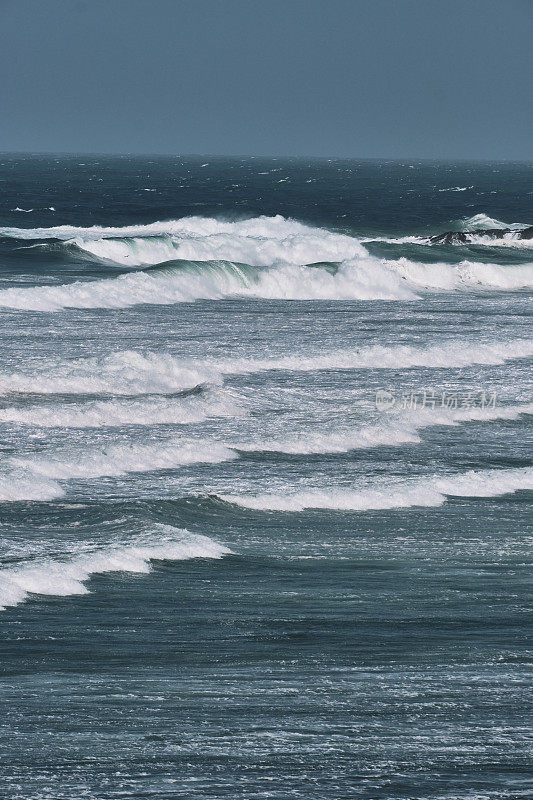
left=0, top=0, right=533, bottom=161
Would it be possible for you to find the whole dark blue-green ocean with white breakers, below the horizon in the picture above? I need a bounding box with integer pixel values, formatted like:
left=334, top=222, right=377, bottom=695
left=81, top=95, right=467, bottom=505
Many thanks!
left=0, top=154, right=533, bottom=800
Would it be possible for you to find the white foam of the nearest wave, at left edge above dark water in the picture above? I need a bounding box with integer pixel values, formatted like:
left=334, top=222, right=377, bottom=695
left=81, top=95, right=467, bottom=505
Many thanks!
left=0, top=525, right=231, bottom=610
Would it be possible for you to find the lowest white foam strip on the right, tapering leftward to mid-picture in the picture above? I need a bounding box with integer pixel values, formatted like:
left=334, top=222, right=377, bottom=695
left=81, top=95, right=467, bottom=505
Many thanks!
left=219, top=467, right=533, bottom=511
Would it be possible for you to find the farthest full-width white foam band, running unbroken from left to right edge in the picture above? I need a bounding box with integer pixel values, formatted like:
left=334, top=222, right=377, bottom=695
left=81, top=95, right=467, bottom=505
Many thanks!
left=0, top=256, right=533, bottom=312
